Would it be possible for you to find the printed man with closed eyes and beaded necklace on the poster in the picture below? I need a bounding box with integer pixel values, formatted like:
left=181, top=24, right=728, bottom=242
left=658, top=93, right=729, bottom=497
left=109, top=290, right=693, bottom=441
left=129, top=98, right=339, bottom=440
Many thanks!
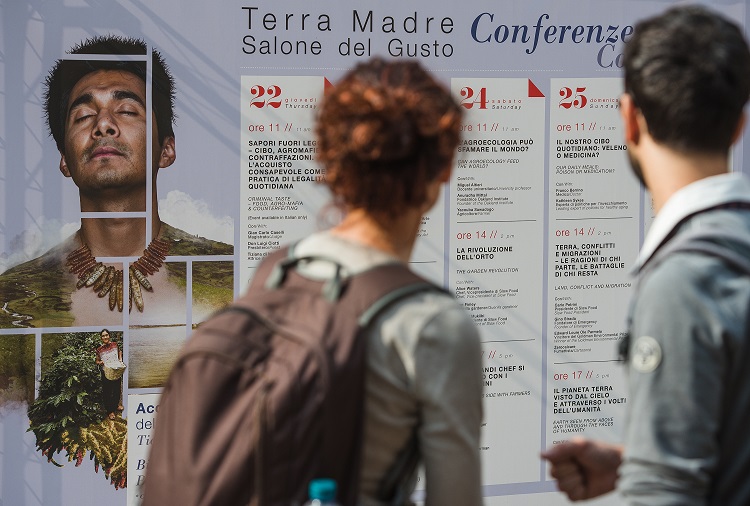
left=0, top=36, right=233, bottom=327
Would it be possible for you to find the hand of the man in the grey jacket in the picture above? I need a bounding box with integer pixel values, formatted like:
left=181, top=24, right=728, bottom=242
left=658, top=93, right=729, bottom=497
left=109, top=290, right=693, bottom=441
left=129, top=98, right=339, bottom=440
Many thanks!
left=542, top=437, right=622, bottom=501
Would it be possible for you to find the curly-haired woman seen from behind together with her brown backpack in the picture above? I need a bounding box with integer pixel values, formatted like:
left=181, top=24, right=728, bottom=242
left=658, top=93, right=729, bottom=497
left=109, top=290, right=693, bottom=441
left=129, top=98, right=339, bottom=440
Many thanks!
left=143, top=59, right=482, bottom=506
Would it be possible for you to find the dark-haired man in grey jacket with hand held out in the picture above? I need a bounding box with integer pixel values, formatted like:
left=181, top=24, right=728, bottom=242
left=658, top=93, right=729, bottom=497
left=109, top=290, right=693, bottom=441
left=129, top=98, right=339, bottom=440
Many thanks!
left=543, top=6, right=750, bottom=506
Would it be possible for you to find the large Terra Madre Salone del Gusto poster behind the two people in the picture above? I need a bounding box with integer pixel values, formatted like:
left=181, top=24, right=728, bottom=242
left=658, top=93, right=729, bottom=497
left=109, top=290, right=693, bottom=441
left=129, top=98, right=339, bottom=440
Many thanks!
left=0, top=0, right=748, bottom=505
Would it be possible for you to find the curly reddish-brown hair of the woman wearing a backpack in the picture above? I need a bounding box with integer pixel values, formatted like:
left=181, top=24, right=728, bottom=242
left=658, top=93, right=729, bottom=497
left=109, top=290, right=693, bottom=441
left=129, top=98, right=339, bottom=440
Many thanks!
left=316, top=58, right=462, bottom=217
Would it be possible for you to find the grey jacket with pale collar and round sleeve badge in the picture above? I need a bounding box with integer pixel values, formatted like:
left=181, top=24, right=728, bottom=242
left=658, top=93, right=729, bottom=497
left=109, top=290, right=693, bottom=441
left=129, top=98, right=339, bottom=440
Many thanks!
left=618, top=175, right=750, bottom=506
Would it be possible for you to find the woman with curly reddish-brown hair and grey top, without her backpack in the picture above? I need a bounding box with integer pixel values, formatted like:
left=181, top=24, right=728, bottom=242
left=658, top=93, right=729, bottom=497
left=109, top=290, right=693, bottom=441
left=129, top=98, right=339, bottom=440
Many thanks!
left=295, top=58, right=482, bottom=506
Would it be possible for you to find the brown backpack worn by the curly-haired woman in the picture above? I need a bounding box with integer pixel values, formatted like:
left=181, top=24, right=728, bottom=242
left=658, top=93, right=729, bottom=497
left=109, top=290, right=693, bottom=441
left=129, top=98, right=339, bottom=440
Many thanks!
left=143, top=248, right=440, bottom=506
